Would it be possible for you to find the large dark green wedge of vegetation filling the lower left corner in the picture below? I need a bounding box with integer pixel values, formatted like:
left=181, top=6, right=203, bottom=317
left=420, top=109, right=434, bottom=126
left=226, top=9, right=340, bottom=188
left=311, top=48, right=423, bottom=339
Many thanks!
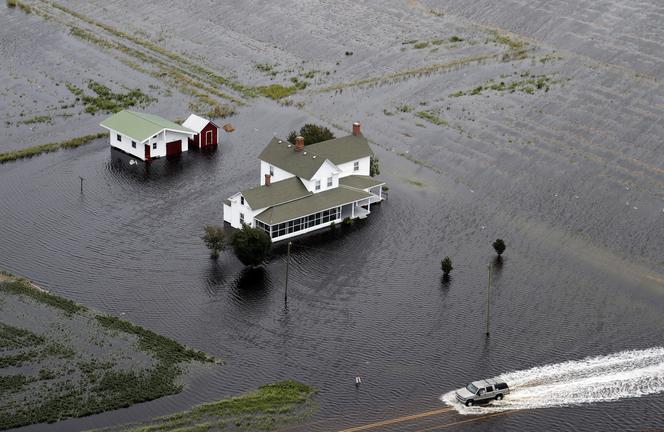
left=0, top=273, right=214, bottom=430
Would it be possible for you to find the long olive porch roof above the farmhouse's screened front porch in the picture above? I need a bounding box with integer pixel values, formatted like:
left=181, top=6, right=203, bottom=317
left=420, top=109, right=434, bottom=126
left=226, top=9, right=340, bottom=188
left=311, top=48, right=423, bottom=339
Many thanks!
left=256, top=186, right=373, bottom=225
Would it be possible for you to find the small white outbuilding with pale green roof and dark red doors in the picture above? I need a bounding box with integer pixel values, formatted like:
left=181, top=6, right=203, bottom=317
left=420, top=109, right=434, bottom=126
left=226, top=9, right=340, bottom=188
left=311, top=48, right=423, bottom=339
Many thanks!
left=99, top=110, right=195, bottom=161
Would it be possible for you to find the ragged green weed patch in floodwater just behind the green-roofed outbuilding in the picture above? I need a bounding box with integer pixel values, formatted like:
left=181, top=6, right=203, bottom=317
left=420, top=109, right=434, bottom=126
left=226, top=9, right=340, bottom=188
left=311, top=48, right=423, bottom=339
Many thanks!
left=65, top=80, right=157, bottom=114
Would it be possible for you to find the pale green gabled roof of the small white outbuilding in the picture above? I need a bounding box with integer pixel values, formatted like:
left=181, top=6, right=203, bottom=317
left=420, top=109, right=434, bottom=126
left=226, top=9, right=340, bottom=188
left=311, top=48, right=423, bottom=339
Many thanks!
left=99, top=110, right=195, bottom=142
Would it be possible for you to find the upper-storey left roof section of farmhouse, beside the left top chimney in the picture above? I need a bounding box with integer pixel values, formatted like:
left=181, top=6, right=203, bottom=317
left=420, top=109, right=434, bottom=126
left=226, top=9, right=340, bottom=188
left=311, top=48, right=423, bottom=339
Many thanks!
left=258, top=137, right=325, bottom=180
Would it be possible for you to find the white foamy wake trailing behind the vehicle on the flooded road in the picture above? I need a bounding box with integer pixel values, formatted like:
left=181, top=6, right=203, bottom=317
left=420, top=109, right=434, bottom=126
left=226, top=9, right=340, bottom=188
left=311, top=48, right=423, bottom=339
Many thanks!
left=440, top=347, right=664, bottom=414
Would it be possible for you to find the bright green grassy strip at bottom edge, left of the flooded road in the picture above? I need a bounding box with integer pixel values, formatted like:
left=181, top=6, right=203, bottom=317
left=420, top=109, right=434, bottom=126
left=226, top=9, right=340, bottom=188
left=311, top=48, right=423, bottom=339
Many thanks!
left=116, top=381, right=316, bottom=432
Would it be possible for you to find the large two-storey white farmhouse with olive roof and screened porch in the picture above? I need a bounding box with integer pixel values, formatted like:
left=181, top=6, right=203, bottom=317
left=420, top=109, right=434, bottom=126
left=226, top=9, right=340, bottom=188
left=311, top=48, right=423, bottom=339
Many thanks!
left=224, top=123, right=385, bottom=242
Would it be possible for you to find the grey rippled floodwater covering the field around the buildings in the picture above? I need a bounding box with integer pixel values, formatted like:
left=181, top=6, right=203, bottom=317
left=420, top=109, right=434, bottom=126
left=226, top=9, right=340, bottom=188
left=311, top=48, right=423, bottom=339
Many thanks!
left=0, top=0, right=664, bottom=431
